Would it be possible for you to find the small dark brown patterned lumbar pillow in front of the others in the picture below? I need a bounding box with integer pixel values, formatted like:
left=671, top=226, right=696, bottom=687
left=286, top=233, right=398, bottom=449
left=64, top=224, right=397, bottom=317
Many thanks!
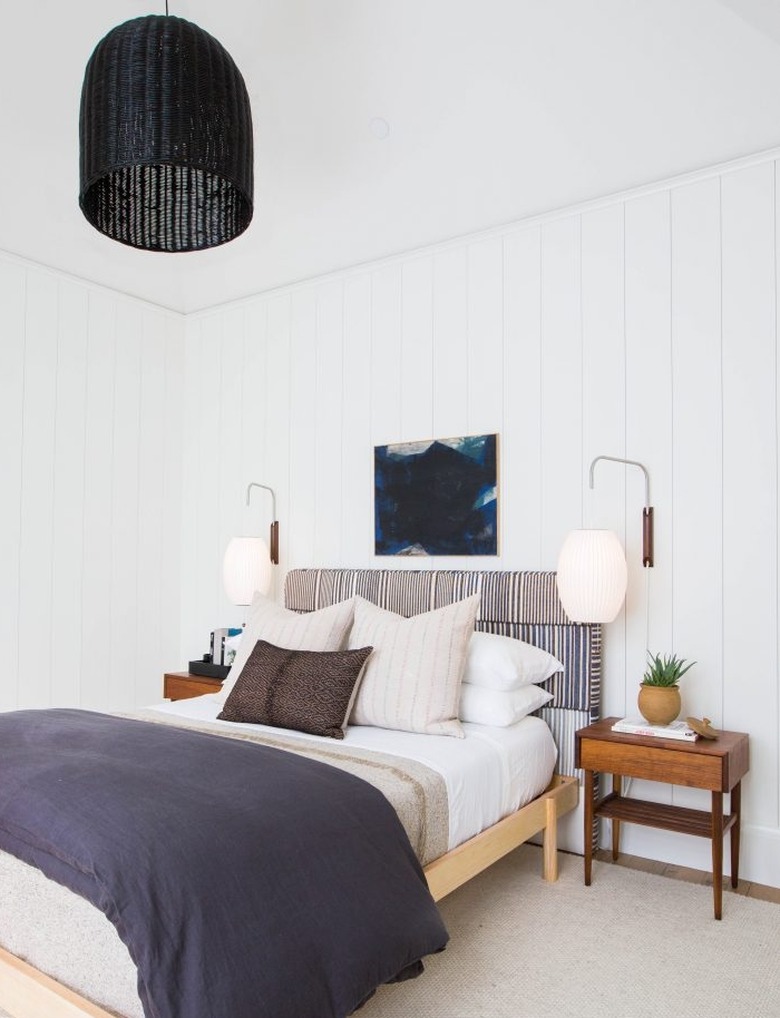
left=218, top=639, right=372, bottom=739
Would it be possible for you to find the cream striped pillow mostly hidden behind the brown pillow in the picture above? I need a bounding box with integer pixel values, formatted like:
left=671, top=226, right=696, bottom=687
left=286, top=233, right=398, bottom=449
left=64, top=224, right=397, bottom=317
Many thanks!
left=217, top=593, right=354, bottom=703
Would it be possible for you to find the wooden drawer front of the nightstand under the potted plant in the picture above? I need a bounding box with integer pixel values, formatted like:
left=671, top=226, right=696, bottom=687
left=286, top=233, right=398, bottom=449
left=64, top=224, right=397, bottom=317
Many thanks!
left=579, top=739, right=726, bottom=791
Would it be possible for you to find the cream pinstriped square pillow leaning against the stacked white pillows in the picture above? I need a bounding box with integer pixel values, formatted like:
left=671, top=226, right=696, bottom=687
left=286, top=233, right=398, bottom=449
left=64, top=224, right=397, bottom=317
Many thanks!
left=349, top=595, right=480, bottom=739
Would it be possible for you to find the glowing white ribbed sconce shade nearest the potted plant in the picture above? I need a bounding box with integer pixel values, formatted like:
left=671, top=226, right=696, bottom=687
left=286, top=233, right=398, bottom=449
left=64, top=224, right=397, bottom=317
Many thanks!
left=557, top=530, right=628, bottom=622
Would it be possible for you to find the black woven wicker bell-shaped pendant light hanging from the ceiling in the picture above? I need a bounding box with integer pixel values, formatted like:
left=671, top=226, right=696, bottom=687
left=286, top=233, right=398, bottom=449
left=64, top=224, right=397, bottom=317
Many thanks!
left=78, top=14, right=253, bottom=251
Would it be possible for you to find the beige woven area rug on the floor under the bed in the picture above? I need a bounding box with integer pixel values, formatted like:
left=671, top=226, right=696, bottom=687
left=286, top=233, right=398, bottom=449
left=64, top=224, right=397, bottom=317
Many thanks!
left=0, top=846, right=780, bottom=1018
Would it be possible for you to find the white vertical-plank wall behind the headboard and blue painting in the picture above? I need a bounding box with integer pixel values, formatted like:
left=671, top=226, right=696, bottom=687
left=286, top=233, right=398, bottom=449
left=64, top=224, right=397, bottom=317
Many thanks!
left=183, top=148, right=780, bottom=886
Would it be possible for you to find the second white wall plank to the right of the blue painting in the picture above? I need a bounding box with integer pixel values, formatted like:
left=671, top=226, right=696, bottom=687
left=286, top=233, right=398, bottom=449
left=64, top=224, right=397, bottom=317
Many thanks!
left=541, top=216, right=582, bottom=569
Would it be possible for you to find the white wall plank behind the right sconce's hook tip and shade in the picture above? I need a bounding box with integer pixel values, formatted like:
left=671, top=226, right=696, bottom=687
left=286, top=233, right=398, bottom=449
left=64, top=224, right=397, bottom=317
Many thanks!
left=580, top=205, right=634, bottom=716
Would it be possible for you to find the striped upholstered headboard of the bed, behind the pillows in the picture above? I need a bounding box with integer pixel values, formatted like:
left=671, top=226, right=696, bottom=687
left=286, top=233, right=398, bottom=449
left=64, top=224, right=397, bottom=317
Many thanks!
left=284, top=569, right=601, bottom=775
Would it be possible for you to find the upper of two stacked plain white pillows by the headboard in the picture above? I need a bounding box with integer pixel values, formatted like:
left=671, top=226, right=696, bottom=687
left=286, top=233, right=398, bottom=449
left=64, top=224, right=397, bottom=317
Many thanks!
left=463, top=633, right=563, bottom=692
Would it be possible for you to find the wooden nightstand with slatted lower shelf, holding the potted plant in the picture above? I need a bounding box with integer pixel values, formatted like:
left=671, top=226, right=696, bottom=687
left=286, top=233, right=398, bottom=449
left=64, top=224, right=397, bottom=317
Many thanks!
left=574, top=718, right=749, bottom=919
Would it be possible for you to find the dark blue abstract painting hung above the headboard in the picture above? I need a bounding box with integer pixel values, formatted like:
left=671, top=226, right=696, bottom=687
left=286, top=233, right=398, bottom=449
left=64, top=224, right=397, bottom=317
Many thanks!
left=374, top=435, right=498, bottom=555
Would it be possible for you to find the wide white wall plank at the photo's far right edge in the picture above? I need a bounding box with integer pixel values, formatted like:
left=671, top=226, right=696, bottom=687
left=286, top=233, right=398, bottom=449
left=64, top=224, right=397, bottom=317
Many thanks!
left=721, top=164, right=778, bottom=824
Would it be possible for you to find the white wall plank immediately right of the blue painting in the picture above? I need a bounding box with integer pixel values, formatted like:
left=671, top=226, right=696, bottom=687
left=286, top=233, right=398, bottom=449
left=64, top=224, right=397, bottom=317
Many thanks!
left=499, top=228, right=542, bottom=569
